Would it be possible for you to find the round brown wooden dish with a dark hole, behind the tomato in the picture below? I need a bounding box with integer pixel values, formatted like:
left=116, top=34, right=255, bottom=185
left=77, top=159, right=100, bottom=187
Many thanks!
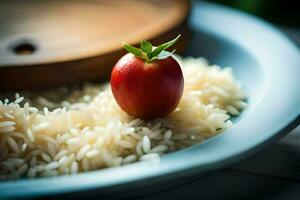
left=0, top=0, right=190, bottom=91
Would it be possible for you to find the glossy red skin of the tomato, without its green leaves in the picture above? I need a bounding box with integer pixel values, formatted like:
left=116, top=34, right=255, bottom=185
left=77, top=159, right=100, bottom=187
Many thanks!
left=110, top=53, right=184, bottom=119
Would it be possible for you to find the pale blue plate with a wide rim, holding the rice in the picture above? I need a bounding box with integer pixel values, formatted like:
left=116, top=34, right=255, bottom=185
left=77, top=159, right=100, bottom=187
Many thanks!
left=0, top=2, right=300, bottom=198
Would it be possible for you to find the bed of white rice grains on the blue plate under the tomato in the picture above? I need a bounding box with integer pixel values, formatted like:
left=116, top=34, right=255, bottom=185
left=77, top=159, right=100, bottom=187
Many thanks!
left=0, top=58, right=247, bottom=179
